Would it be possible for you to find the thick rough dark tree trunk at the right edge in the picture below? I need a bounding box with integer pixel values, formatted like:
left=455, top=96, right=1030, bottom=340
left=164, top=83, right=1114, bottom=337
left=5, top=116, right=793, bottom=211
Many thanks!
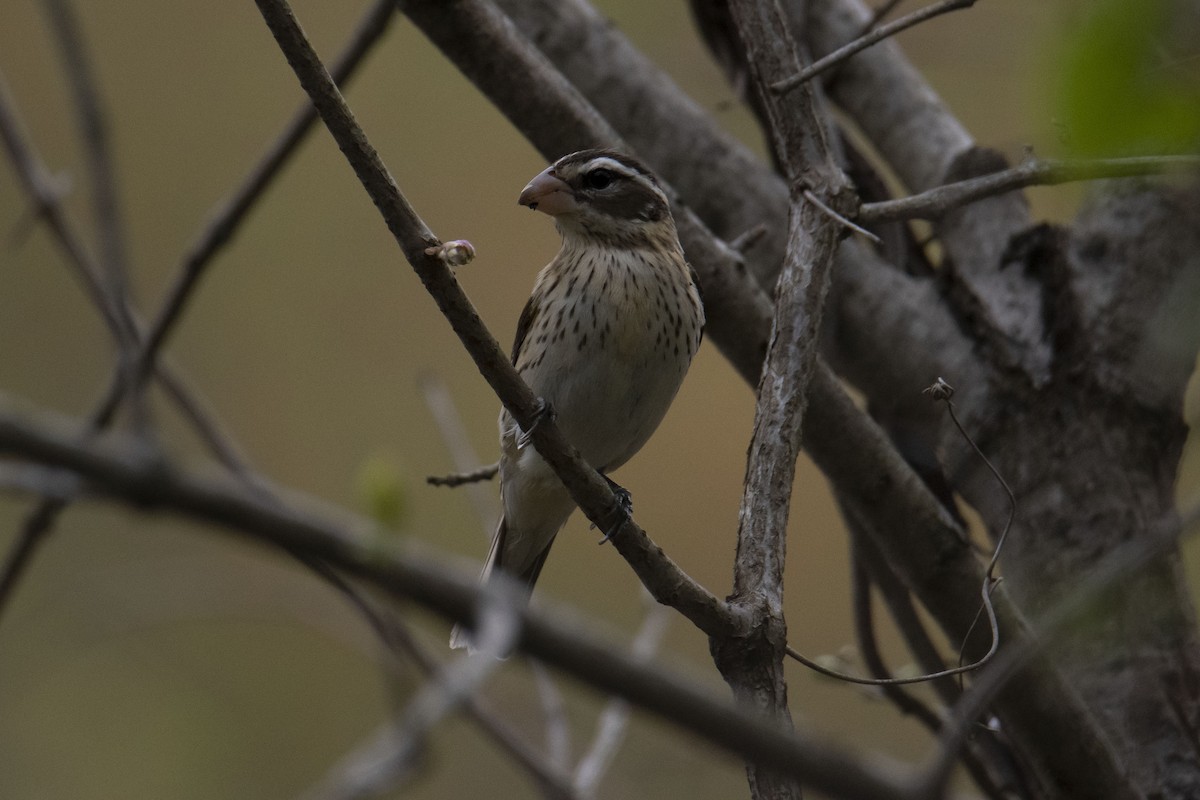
left=946, top=185, right=1200, bottom=799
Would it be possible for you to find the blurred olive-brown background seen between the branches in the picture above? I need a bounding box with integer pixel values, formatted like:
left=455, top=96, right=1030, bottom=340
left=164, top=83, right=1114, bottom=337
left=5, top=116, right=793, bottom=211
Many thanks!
left=0, top=0, right=1200, bottom=800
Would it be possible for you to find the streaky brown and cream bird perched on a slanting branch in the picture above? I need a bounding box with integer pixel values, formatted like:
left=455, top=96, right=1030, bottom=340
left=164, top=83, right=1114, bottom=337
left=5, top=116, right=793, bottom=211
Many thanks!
left=450, top=149, right=704, bottom=648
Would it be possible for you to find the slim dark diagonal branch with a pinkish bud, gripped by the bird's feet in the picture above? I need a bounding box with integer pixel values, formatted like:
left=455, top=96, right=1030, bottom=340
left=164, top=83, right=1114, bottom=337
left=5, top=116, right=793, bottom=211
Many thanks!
left=256, top=0, right=737, bottom=633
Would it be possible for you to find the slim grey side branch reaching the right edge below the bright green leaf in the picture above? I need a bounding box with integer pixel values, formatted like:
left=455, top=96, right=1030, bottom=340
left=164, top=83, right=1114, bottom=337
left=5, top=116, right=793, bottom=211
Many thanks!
left=856, top=156, right=1200, bottom=224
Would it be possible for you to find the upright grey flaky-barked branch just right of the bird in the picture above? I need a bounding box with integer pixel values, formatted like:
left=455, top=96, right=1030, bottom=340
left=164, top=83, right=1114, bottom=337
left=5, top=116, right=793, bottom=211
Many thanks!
left=710, top=0, right=857, bottom=798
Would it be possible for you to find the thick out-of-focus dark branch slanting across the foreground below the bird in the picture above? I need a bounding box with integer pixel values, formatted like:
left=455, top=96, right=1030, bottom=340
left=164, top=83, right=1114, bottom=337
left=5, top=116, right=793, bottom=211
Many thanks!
left=0, top=409, right=910, bottom=800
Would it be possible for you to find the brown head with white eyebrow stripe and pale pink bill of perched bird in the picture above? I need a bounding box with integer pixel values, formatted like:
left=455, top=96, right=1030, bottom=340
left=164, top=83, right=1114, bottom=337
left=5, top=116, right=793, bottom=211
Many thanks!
left=518, top=150, right=676, bottom=247
